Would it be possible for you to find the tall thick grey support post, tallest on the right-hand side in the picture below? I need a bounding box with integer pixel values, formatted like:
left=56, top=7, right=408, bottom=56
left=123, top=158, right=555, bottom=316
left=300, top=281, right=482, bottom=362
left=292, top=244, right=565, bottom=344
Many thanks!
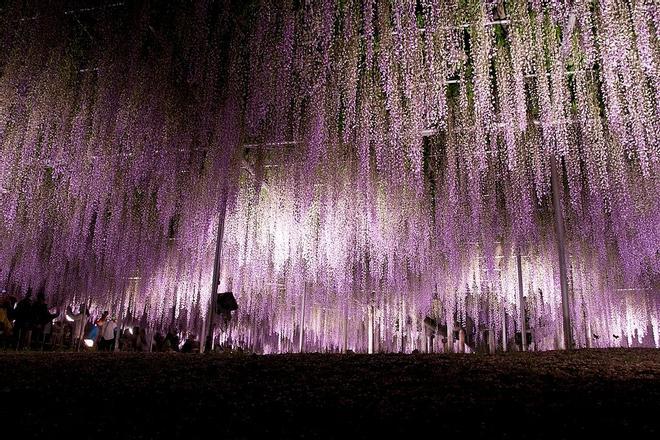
left=550, top=154, right=573, bottom=350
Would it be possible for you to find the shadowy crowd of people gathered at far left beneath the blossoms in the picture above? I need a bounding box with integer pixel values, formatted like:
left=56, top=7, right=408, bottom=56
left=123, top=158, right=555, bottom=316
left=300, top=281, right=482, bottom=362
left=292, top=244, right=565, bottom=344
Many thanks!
left=0, top=289, right=199, bottom=353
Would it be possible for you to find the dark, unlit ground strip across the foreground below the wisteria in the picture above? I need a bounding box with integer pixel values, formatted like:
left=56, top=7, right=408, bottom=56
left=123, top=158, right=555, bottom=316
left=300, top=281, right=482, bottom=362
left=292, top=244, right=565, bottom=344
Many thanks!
left=0, top=349, right=660, bottom=440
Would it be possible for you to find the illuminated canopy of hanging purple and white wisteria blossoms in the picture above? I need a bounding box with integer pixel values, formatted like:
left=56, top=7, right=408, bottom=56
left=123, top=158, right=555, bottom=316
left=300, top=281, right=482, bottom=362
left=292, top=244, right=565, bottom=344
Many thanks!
left=0, top=0, right=660, bottom=352
